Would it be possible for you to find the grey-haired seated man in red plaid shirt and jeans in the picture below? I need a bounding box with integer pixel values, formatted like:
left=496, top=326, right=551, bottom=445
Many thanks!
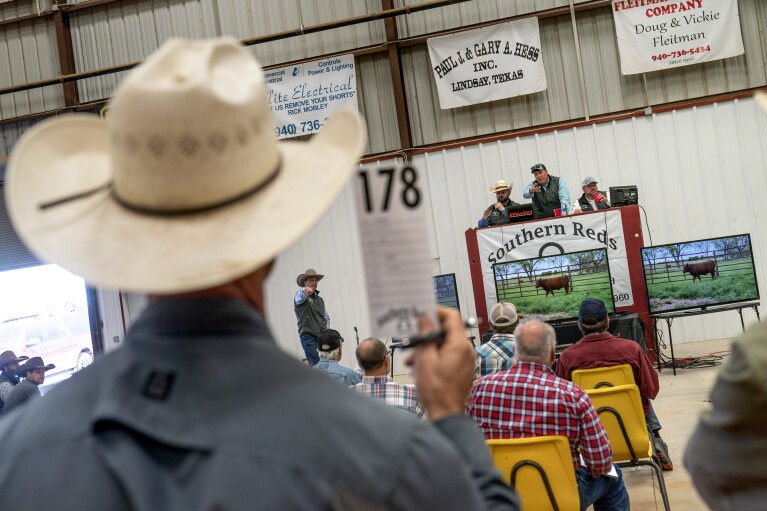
left=468, top=321, right=630, bottom=511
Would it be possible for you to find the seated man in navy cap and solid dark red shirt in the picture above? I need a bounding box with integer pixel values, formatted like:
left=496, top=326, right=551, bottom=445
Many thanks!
left=556, top=298, right=674, bottom=470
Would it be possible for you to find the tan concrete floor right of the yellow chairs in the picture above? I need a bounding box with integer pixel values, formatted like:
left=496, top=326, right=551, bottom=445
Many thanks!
left=616, top=339, right=731, bottom=511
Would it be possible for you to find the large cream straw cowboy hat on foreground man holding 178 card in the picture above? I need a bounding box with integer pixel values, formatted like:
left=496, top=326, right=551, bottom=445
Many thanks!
left=5, top=38, right=365, bottom=293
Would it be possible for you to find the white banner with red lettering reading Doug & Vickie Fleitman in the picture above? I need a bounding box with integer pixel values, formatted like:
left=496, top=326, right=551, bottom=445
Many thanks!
left=613, top=0, right=744, bottom=75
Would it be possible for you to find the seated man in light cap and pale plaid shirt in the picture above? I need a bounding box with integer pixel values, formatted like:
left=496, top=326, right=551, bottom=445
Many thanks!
left=477, top=302, right=519, bottom=377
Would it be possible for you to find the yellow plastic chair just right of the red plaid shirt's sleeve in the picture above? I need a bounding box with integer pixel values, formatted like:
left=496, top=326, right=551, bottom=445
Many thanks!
left=586, top=384, right=671, bottom=511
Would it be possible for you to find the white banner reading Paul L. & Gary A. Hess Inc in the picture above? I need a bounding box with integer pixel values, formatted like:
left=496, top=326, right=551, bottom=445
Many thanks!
left=426, top=17, right=546, bottom=110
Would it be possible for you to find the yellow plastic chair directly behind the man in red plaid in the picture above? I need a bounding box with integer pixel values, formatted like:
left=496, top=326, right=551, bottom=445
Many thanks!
left=487, top=436, right=581, bottom=511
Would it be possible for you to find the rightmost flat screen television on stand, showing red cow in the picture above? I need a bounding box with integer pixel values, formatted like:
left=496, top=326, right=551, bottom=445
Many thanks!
left=641, top=234, right=759, bottom=314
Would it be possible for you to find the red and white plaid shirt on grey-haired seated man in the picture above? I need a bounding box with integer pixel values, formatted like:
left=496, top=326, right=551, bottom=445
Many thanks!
left=467, top=362, right=612, bottom=476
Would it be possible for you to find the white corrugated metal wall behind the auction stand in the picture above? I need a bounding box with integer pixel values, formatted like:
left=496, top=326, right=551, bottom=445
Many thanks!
left=268, top=99, right=767, bottom=365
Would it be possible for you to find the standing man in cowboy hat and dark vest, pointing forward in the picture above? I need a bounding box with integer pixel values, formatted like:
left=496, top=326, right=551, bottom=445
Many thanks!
left=293, top=268, right=330, bottom=366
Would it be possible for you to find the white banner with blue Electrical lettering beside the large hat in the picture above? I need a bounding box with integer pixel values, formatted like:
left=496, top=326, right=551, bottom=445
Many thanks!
left=264, top=55, right=358, bottom=138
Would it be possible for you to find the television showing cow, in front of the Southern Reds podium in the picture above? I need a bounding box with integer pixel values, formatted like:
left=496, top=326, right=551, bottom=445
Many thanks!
left=493, top=248, right=615, bottom=322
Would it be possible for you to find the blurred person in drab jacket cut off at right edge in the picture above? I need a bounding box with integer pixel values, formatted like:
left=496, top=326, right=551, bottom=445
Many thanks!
left=684, top=320, right=767, bottom=511
